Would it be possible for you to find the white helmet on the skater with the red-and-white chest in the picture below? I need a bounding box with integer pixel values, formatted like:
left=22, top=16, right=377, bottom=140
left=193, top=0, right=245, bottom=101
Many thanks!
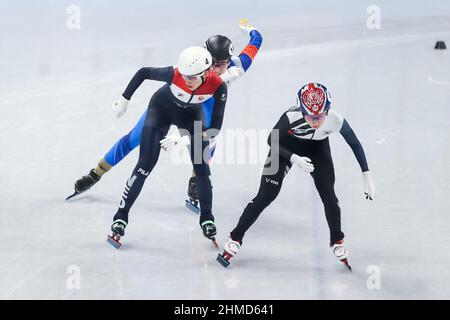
left=178, top=47, right=212, bottom=76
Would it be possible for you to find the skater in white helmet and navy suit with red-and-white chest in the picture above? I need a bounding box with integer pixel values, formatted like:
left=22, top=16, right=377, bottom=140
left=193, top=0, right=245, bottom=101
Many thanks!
left=108, top=47, right=227, bottom=248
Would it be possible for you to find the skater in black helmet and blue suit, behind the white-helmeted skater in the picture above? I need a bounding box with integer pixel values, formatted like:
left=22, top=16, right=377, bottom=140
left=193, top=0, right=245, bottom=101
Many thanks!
left=66, top=19, right=262, bottom=213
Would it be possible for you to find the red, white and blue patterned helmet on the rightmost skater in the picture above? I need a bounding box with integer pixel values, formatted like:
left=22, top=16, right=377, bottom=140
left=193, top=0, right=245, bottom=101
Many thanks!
left=297, top=83, right=331, bottom=116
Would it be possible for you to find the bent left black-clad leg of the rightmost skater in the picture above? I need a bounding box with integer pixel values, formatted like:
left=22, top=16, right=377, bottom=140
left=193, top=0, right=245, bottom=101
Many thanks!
left=230, top=155, right=291, bottom=243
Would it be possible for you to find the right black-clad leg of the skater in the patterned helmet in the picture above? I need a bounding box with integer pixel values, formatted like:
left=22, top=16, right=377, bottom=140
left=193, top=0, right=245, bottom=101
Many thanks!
left=311, top=139, right=344, bottom=244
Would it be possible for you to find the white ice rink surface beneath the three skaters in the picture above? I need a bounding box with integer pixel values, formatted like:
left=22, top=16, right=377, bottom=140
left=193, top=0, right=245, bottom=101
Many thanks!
left=0, top=0, right=450, bottom=299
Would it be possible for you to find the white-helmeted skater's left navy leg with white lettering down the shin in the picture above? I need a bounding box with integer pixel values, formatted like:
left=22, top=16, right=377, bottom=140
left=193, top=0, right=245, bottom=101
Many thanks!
left=114, top=108, right=169, bottom=222
